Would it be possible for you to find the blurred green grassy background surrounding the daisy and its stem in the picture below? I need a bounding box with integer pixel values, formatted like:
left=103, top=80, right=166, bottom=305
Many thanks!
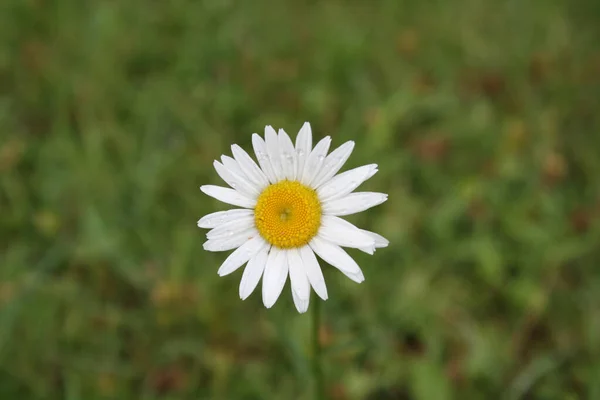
left=0, top=0, right=600, bottom=400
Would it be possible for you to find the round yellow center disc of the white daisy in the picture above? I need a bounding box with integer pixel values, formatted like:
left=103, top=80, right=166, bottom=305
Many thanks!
left=254, top=180, right=321, bottom=249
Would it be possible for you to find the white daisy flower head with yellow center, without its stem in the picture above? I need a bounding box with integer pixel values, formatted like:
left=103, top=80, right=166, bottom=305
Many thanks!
left=198, top=122, right=388, bottom=313
